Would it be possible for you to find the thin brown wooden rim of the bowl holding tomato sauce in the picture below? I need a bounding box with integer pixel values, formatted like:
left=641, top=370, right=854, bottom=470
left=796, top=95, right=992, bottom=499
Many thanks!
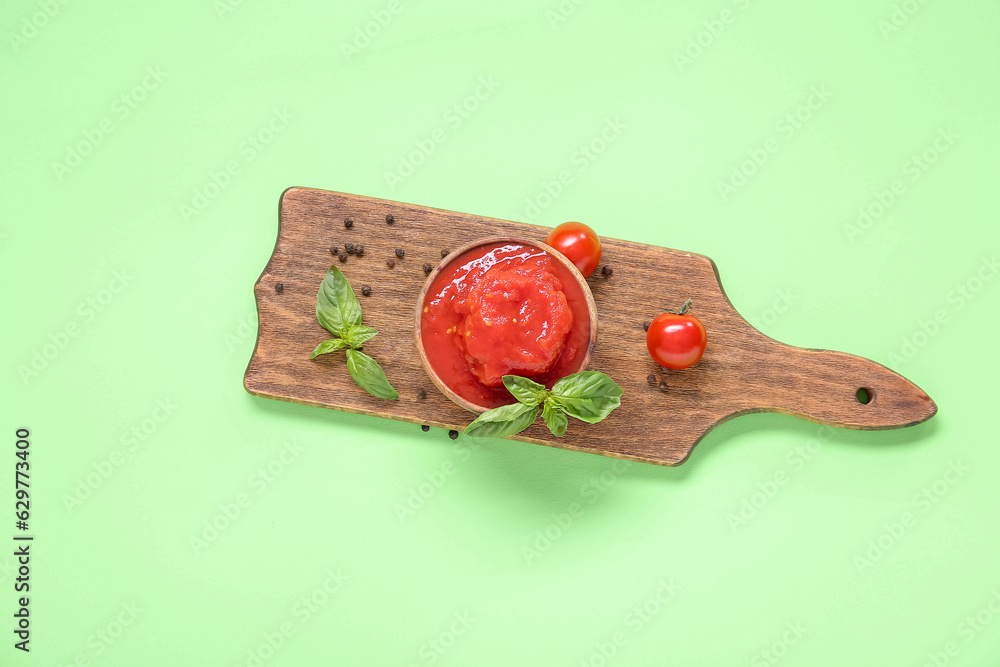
left=413, top=236, right=597, bottom=412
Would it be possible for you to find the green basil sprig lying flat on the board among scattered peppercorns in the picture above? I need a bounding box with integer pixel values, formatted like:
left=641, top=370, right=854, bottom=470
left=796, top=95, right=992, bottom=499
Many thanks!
left=309, top=266, right=399, bottom=400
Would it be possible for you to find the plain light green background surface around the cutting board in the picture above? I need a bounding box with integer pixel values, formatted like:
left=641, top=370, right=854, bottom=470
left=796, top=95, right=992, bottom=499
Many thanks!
left=0, top=0, right=1000, bottom=666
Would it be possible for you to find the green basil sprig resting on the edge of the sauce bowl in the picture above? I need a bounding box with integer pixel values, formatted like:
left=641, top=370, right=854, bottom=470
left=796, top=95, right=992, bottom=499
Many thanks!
left=465, top=371, right=623, bottom=438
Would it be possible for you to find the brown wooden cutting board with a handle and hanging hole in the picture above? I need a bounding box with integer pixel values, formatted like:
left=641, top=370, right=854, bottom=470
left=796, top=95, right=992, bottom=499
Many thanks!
left=244, top=188, right=937, bottom=465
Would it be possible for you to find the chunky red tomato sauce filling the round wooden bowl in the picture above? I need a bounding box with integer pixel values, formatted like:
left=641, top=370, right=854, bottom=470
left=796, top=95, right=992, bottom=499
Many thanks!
left=420, top=243, right=590, bottom=408
